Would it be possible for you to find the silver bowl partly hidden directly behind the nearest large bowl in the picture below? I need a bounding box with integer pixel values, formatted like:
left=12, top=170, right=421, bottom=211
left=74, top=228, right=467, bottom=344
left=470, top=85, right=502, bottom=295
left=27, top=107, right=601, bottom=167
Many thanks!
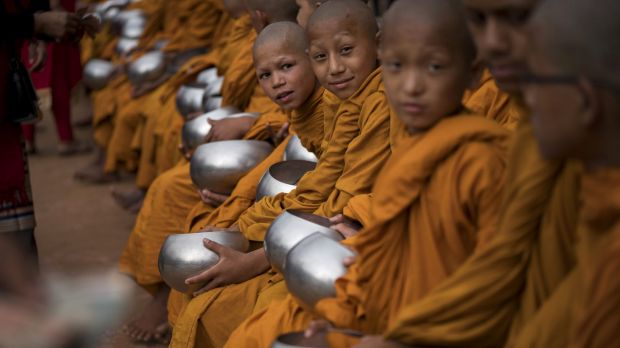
left=264, top=210, right=343, bottom=272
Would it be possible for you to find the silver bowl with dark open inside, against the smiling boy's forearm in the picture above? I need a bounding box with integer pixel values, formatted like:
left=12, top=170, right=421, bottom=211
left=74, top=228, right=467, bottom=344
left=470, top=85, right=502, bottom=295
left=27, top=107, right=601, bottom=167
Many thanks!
left=256, top=160, right=316, bottom=201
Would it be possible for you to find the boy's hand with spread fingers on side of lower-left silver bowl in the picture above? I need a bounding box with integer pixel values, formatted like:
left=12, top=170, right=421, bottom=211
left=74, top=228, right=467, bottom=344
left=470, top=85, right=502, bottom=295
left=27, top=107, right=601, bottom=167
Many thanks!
left=185, top=242, right=269, bottom=296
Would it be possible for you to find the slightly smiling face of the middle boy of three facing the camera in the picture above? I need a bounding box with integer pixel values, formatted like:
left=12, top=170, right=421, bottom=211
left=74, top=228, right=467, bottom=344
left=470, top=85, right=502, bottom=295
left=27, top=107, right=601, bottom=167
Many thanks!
left=308, top=18, right=377, bottom=99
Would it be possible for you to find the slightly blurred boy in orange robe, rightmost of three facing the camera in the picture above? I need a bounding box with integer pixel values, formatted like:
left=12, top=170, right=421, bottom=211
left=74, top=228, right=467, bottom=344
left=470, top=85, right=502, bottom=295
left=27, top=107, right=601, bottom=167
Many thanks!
left=227, top=0, right=509, bottom=347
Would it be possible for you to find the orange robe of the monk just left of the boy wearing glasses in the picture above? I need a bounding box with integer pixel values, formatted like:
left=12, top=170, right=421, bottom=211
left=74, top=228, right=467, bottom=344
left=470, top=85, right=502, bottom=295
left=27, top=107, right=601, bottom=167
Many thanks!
left=376, top=117, right=580, bottom=347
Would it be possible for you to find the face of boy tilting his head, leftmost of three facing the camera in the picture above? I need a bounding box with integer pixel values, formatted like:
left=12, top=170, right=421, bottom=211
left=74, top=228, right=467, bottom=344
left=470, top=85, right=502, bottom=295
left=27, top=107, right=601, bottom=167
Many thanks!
left=254, top=43, right=316, bottom=110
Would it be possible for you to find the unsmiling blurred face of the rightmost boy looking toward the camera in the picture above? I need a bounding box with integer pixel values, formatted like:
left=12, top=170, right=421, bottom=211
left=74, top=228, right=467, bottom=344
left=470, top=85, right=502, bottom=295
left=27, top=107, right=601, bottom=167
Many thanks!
left=379, top=21, right=473, bottom=133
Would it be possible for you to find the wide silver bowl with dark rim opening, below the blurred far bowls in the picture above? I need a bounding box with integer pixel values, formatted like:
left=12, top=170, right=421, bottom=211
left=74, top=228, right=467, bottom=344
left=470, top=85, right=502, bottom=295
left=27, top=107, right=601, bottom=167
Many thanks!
left=189, top=140, right=273, bottom=194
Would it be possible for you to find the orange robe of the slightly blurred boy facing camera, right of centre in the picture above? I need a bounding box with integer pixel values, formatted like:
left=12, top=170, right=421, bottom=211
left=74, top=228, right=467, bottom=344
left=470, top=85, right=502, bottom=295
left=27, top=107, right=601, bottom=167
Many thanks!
left=227, top=114, right=508, bottom=347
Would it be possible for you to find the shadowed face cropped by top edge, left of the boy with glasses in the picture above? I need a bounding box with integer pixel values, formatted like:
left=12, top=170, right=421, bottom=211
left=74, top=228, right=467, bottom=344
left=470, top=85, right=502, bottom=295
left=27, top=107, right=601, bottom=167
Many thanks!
left=463, top=0, right=538, bottom=93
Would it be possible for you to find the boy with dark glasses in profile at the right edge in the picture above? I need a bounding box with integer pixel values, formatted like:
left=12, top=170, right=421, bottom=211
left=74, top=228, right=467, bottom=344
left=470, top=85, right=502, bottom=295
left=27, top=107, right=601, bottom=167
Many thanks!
left=510, top=0, right=620, bottom=347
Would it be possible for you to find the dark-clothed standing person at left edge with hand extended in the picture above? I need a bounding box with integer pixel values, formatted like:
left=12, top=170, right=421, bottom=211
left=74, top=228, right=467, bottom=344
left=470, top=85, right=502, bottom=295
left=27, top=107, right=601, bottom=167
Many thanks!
left=0, top=0, right=93, bottom=263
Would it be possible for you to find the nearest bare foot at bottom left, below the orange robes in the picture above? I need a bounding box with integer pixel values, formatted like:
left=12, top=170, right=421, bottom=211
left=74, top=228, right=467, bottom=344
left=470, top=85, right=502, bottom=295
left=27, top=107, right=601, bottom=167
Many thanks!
left=123, top=285, right=170, bottom=344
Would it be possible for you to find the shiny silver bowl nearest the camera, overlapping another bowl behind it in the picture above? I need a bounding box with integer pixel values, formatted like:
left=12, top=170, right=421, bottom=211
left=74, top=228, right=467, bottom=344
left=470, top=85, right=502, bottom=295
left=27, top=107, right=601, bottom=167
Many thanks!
left=284, top=233, right=355, bottom=309
